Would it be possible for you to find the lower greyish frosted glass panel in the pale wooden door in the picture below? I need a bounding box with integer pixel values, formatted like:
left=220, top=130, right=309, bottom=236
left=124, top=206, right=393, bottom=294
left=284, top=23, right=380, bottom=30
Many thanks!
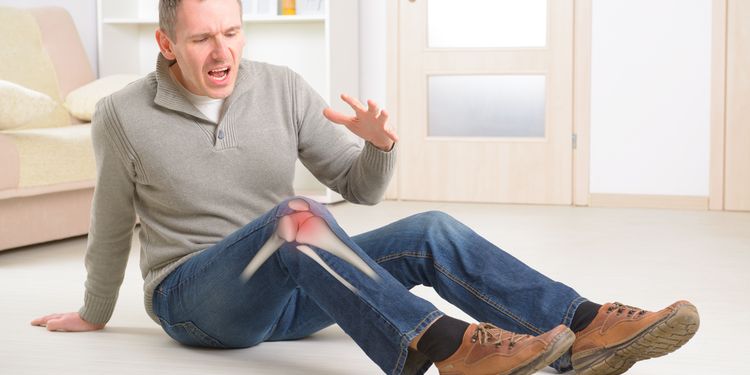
left=428, top=75, right=546, bottom=137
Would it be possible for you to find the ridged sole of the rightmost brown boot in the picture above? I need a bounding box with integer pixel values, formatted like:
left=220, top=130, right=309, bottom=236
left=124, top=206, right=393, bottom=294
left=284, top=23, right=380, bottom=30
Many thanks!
left=573, top=304, right=700, bottom=375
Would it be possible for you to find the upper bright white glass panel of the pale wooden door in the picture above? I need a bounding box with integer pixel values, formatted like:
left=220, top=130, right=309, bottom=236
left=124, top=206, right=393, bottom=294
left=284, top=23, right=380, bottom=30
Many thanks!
left=427, top=0, right=547, bottom=48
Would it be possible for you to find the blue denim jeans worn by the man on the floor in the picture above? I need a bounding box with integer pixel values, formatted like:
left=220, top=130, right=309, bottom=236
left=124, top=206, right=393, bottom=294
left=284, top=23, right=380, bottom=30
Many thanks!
left=153, top=197, right=585, bottom=374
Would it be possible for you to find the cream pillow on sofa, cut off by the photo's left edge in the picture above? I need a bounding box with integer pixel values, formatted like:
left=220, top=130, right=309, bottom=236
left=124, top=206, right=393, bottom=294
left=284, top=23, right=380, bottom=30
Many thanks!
left=0, top=80, right=57, bottom=130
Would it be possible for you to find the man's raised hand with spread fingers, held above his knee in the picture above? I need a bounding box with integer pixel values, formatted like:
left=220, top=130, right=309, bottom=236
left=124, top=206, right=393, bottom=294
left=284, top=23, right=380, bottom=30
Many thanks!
left=323, top=94, right=398, bottom=151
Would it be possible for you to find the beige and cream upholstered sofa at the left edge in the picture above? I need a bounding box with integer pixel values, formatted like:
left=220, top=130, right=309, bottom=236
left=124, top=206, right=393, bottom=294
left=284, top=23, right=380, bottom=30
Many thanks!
left=0, top=6, right=96, bottom=250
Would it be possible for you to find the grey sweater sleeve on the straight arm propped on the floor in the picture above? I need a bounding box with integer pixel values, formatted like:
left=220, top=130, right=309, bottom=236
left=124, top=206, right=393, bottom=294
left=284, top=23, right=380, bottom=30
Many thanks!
left=78, top=97, right=135, bottom=324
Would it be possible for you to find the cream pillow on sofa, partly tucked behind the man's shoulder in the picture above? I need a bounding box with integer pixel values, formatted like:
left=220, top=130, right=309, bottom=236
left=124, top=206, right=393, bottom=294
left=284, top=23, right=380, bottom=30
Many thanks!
left=65, top=74, right=141, bottom=121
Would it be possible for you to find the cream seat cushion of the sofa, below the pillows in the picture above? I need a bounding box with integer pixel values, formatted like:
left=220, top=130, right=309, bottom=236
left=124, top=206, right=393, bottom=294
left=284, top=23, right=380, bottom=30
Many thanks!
left=0, top=124, right=96, bottom=188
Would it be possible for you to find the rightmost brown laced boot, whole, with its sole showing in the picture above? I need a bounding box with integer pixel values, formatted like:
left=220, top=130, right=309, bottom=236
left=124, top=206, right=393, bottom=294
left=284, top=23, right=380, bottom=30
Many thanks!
left=572, top=301, right=700, bottom=375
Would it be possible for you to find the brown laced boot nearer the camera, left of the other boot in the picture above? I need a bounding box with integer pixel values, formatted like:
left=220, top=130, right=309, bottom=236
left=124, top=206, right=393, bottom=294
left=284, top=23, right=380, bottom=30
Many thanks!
left=435, top=323, right=575, bottom=375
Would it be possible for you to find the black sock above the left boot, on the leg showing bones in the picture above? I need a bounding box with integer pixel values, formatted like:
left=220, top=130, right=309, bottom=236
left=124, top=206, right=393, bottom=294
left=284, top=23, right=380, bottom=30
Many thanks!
left=417, top=315, right=469, bottom=362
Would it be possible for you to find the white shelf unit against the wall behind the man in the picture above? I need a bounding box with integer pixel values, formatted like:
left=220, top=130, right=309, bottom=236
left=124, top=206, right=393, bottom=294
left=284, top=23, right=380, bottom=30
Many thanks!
left=97, top=0, right=359, bottom=203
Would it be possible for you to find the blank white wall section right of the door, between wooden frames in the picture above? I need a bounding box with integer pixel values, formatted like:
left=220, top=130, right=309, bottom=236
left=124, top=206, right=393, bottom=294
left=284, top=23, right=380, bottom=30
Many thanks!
left=590, top=0, right=711, bottom=196
